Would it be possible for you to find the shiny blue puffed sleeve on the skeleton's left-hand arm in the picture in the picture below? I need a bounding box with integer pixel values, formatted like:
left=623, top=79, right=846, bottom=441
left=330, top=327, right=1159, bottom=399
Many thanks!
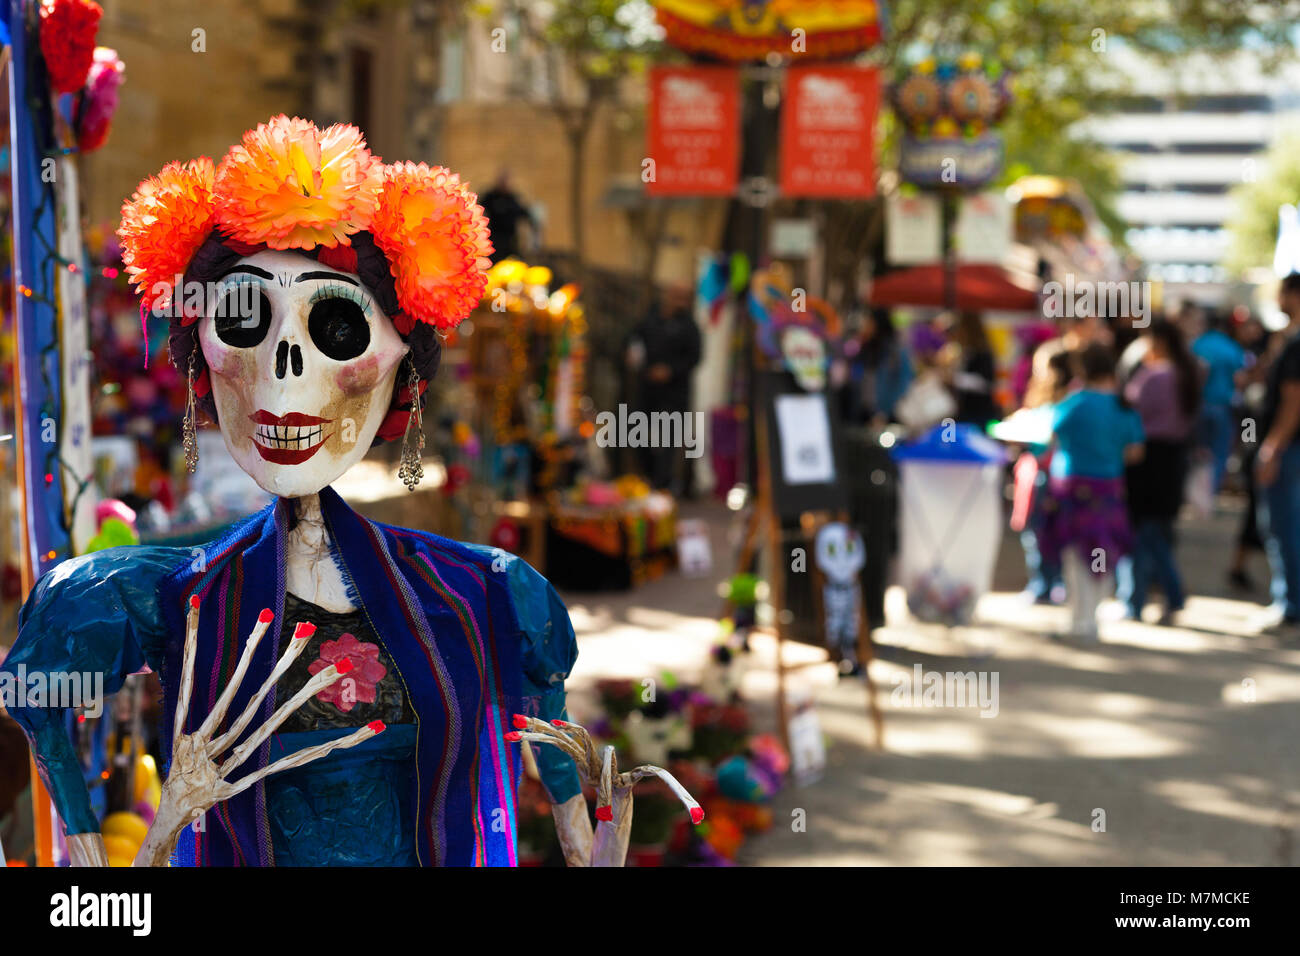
left=0, top=545, right=190, bottom=834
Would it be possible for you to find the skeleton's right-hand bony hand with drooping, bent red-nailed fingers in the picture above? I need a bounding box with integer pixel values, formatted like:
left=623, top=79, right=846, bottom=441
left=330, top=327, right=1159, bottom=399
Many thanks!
left=506, top=714, right=705, bottom=866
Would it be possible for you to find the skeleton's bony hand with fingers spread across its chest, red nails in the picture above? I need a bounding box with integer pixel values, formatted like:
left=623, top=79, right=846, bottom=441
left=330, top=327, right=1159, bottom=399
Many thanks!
left=135, top=596, right=384, bottom=866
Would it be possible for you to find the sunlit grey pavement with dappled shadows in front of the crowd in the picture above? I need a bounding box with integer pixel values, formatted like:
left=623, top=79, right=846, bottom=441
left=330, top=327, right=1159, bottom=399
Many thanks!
left=566, top=507, right=1300, bottom=865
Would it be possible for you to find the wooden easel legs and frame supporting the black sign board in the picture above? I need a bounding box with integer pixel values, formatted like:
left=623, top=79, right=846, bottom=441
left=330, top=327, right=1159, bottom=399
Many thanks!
left=723, top=411, right=884, bottom=752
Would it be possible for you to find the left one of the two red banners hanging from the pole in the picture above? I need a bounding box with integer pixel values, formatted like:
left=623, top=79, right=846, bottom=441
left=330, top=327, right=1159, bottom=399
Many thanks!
left=642, top=66, right=740, bottom=196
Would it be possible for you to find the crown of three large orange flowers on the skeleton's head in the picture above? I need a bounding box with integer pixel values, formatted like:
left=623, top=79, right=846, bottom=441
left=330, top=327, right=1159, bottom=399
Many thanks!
left=117, top=114, right=493, bottom=336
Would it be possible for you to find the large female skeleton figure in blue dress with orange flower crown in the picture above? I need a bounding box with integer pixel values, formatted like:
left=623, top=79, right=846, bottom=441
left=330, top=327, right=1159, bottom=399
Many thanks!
left=4, top=116, right=702, bottom=865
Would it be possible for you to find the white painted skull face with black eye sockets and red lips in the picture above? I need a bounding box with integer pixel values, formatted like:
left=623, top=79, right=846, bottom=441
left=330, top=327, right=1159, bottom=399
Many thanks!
left=199, top=251, right=408, bottom=498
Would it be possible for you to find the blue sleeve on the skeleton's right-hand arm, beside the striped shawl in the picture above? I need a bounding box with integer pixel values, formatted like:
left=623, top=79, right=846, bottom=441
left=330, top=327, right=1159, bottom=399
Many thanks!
left=469, top=545, right=582, bottom=804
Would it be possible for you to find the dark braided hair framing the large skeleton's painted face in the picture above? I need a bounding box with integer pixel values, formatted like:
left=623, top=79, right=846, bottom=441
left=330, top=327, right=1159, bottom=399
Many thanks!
left=168, top=232, right=442, bottom=444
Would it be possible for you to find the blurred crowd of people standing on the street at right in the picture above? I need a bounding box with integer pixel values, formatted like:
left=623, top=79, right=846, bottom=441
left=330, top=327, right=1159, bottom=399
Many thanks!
left=842, top=273, right=1300, bottom=641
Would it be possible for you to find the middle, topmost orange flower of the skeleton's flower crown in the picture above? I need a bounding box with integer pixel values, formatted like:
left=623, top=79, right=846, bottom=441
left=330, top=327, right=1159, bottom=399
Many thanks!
left=215, top=114, right=382, bottom=250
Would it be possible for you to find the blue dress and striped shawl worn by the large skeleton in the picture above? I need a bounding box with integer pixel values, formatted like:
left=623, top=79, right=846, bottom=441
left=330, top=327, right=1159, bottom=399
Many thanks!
left=0, top=489, right=580, bottom=866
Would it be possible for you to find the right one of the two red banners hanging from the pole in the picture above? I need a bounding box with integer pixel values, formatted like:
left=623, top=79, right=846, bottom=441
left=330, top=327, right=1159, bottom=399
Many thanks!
left=781, top=66, right=880, bottom=199
